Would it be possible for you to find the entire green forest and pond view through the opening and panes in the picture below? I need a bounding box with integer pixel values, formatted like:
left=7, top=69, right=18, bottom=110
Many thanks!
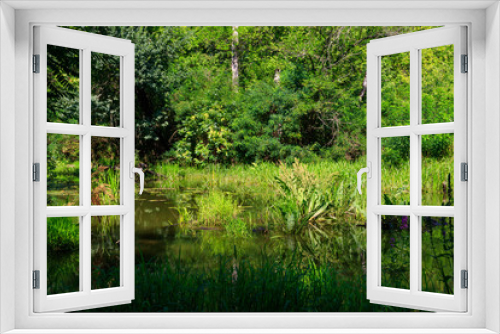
left=47, top=26, right=454, bottom=312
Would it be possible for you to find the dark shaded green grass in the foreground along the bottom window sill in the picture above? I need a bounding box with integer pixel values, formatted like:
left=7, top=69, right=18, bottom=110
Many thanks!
left=82, top=254, right=416, bottom=312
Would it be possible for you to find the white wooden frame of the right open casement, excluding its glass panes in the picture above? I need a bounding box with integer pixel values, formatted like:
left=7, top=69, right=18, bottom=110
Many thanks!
left=367, top=26, right=468, bottom=312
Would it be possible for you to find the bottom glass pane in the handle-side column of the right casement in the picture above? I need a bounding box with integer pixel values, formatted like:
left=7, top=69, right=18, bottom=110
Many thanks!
left=381, top=216, right=410, bottom=289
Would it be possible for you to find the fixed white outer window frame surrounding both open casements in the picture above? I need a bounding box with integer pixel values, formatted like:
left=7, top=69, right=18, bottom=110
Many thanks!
left=0, top=1, right=500, bottom=333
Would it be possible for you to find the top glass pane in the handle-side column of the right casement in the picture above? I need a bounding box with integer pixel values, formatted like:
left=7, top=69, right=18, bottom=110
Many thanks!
left=380, top=52, right=410, bottom=126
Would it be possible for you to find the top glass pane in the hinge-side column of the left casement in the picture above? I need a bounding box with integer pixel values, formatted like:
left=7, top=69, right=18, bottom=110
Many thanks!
left=47, top=45, right=80, bottom=124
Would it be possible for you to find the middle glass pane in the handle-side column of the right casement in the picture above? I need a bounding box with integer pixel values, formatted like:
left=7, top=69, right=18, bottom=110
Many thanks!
left=380, top=137, right=410, bottom=205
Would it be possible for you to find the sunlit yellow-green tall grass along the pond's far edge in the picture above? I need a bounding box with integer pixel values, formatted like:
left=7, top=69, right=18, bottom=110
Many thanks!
left=148, top=160, right=372, bottom=232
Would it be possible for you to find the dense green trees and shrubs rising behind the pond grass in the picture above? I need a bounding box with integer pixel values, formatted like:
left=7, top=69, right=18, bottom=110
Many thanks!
left=48, top=27, right=453, bottom=165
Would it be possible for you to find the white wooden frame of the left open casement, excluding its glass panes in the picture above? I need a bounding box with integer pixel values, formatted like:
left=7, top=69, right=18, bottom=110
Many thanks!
left=33, top=26, right=135, bottom=312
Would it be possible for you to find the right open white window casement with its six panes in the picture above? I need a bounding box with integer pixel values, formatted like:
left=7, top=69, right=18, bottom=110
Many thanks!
left=367, top=26, right=467, bottom=312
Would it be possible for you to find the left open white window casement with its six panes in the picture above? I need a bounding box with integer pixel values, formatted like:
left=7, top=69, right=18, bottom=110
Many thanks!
left=33, top=26, right=139, bottom=312
